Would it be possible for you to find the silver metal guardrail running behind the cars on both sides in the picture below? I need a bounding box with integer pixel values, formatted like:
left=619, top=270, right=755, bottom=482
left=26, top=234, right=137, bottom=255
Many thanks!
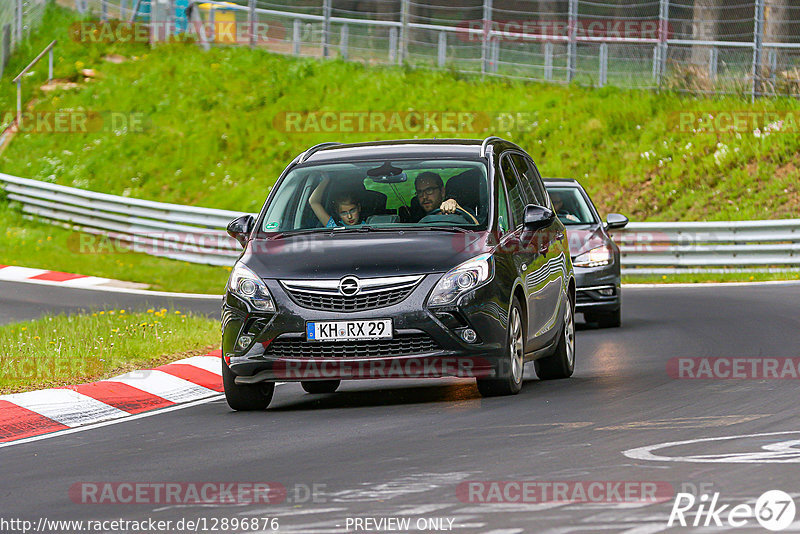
left=0, top=173, right=800, bottom=274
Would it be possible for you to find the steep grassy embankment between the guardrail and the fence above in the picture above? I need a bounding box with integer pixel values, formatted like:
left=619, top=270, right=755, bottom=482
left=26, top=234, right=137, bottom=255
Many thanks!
left=0, top=5, right=800, bottom=291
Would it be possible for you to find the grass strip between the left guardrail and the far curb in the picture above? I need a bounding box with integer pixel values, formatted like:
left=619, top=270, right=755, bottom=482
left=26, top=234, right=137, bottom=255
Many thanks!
left=0, top=202, right=230, bottom=295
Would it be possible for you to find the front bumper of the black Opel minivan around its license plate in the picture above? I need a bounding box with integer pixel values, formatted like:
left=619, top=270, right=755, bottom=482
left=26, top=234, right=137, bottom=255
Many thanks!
left=222, top=274, right=508, bottom=384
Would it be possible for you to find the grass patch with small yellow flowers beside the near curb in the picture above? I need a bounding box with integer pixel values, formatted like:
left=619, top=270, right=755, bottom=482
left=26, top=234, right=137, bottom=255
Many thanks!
left=0, top=308, right=219, bottom=394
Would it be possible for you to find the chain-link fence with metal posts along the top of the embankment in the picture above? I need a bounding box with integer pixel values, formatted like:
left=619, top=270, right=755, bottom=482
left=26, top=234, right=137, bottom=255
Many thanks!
left=67, top=0, right=800, bottom=96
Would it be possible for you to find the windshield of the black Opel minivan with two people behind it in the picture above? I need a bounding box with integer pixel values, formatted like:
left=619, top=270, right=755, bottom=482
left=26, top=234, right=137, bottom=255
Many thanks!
left=261, top=159, right=489, bottom=233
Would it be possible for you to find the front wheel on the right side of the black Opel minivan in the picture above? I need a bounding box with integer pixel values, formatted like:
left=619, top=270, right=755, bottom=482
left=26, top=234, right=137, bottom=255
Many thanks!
left=476, top=297, right=525, bottom=397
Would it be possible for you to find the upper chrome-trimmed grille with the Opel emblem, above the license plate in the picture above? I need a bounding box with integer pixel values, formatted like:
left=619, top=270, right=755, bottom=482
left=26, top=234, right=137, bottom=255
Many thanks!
left=281, top=276, right=422, bottom=312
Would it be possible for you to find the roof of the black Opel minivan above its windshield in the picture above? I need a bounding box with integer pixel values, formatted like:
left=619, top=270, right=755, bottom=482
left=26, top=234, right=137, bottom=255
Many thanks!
left=299, top=138, right=522, bottom=163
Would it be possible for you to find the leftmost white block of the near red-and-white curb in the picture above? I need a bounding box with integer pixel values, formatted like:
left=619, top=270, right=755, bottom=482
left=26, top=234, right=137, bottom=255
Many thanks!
left=0, top=389, right=130, bottom=427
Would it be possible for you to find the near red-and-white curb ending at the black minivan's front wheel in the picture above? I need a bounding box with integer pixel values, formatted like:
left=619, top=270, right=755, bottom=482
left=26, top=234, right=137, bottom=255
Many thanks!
left=0, top=350, right=223, bottom=443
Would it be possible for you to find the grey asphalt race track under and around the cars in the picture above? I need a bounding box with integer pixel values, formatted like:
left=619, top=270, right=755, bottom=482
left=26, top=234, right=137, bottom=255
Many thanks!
left=0, top=283, right=800, bottom=534
